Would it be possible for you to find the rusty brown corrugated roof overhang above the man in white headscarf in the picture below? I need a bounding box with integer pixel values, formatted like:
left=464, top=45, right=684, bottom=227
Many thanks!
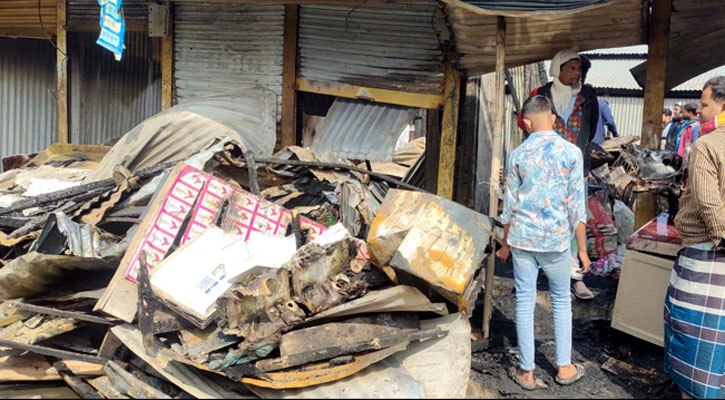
left=446, top=0, right=647, bottom=76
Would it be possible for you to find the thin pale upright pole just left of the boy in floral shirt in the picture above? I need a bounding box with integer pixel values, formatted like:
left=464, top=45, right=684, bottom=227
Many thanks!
left=483, top=15, right=506, bottom=338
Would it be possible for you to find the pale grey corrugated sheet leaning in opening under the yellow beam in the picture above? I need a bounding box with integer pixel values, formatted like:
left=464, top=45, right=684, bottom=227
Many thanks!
left=310, top=98, right=415, bottom=162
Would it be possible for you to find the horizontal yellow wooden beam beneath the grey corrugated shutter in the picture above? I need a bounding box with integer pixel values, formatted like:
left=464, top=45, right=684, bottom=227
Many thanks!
left=297, top=78, right=444, bottom=109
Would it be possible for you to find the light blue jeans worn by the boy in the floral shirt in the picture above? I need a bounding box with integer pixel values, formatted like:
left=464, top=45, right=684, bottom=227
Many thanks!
left=511, top=247, right=572, bottom=371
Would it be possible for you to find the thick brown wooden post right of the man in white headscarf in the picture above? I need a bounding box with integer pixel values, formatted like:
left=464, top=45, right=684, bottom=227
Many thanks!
left=641, top=0, right=672, bottom=149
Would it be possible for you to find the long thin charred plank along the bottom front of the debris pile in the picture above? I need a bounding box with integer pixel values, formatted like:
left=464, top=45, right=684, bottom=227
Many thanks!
left=255, top=329, right=447, bottom=372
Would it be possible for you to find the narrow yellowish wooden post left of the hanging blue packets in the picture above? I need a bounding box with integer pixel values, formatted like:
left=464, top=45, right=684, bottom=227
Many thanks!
left=56, top=0, right=70, bottom=143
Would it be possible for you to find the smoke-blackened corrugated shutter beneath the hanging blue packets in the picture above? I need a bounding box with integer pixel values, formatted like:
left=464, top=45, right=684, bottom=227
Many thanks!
left=68, top=31, right=161, bottom=144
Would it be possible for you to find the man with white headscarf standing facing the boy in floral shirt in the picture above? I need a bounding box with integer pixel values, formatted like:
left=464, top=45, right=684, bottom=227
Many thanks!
left=519, top=49, right=599, bottom=299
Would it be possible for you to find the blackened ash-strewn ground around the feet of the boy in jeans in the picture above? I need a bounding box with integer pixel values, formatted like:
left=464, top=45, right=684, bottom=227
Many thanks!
left=471, top=261, right=679, bottom=399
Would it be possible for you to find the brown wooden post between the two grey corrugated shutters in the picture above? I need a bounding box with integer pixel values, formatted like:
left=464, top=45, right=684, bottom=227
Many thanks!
left=282, top=4, right=299, bottom=146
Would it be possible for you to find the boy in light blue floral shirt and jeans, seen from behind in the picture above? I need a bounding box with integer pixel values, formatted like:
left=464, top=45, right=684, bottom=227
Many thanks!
left=496, top=95, right=591, bottom=390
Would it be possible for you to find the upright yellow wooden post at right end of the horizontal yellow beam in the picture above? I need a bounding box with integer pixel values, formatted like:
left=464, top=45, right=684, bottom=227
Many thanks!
left=437, top=61, right=461, bottom=200
